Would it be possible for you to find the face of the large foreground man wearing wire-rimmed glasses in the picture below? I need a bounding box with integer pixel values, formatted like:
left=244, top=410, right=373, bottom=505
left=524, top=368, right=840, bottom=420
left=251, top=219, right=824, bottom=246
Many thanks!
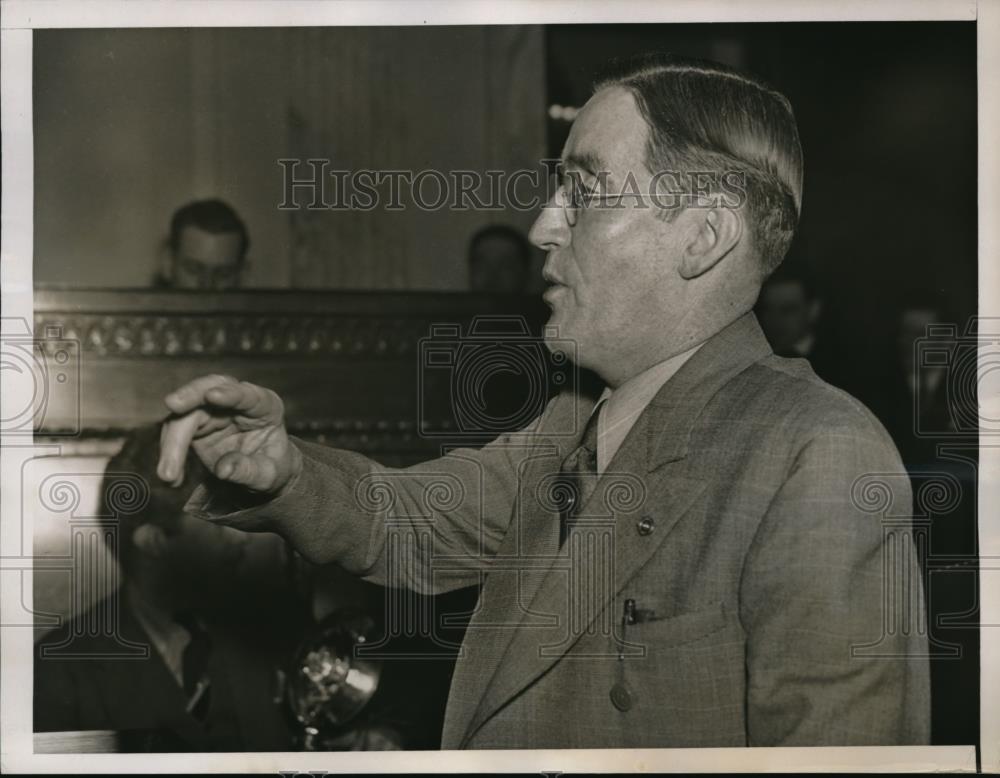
left=529, top=87, right=689, bottom=382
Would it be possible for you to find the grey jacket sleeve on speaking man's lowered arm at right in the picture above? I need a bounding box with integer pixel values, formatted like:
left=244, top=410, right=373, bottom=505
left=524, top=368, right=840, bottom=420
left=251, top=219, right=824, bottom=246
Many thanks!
left=740, top=420, right=930, bottom=746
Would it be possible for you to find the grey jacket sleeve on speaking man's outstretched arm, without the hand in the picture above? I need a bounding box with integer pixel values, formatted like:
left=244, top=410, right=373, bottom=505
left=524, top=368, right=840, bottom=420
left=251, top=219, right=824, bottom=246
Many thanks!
left=186, top=398, right=564, bottom=594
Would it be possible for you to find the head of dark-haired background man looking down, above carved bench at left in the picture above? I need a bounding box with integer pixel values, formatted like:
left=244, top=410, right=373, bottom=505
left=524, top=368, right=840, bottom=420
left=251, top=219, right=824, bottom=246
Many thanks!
left=153, top=200, right=250, bottom=290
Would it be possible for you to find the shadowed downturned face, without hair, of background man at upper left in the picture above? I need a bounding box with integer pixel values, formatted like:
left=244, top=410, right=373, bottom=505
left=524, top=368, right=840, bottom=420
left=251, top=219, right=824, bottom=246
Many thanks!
left=171, top=225, right=242, bottom=289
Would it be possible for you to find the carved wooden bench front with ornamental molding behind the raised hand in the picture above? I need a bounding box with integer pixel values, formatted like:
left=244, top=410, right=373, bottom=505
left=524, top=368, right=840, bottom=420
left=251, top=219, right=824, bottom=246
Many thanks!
left=34, top=290, right=545, bottom=461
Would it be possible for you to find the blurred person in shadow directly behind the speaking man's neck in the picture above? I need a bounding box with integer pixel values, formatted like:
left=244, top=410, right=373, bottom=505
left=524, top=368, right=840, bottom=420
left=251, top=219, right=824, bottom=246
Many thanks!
left=756, top=260, right=845, bottom=387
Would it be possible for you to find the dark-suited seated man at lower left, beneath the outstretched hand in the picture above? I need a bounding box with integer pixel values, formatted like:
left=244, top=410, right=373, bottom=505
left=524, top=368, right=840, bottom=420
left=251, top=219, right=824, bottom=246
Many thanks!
left=34, top=425, right=304, bottom=751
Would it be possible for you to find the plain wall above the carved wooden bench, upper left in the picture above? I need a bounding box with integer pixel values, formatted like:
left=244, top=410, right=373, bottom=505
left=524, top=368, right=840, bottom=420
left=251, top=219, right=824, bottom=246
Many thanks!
left=34, top=26, right=545, bottom=290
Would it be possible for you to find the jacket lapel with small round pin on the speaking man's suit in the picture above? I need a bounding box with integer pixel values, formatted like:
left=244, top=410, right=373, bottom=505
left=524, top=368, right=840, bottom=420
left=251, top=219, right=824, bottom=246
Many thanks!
left=454, top=314, right=770, bottom=748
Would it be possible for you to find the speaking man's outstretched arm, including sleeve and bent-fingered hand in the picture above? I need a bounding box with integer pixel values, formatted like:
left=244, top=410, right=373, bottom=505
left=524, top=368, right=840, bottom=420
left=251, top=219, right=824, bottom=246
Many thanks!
left=158, top=376, right=564, bottom=593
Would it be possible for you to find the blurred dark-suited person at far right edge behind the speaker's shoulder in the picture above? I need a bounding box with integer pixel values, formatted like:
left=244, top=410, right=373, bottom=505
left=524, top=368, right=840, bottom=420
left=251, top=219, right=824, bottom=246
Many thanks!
left=863, top=298, right=979, bottom=743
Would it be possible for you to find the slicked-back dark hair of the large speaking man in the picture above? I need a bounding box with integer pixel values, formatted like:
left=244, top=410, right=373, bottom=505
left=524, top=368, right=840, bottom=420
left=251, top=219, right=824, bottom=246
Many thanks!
left=594, top=54, right=802, bottom=279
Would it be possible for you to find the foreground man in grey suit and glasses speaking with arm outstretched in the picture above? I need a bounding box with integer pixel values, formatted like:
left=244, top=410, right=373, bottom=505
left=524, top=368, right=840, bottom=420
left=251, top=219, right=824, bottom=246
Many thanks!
left=158, top=57, right=929, bottom=748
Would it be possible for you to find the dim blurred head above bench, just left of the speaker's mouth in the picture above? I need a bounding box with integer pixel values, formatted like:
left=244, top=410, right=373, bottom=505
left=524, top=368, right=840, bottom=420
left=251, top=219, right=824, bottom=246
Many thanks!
left=469, top=224, right=531, bottom=294
